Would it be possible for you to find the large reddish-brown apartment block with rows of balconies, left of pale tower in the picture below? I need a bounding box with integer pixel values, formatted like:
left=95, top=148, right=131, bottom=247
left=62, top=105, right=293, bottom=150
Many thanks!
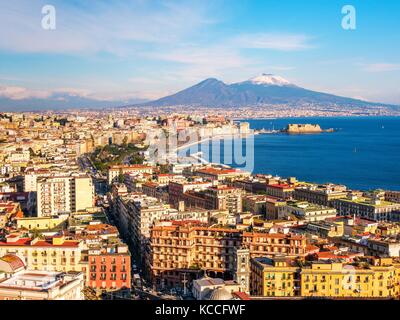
left=146, top=221, right=241, bottom=287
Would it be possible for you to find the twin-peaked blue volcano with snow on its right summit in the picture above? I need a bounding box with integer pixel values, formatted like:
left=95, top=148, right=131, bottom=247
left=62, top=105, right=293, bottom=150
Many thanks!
left=142, top=73, right=391, bottom=107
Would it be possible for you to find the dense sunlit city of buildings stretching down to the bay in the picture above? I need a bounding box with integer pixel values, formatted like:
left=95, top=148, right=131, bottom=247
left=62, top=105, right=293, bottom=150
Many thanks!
left=0, top=107, right=400, bottom=300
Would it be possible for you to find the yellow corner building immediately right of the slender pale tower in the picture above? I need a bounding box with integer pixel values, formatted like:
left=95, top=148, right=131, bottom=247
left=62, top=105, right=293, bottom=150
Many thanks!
left=250, top=257, right=299, bottom=297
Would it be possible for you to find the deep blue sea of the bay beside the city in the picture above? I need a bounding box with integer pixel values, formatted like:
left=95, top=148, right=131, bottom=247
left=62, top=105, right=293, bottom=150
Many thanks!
left=180, top=117, right=400, bottom=190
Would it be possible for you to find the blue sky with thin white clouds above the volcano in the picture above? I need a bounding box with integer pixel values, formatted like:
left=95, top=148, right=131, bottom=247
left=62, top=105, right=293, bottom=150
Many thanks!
left=0, top=0, right=400, bottom=104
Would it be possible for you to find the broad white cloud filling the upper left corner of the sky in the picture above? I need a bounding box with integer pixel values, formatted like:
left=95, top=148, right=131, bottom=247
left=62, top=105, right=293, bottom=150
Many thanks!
left=0, top=0, right=212, bottom=54
